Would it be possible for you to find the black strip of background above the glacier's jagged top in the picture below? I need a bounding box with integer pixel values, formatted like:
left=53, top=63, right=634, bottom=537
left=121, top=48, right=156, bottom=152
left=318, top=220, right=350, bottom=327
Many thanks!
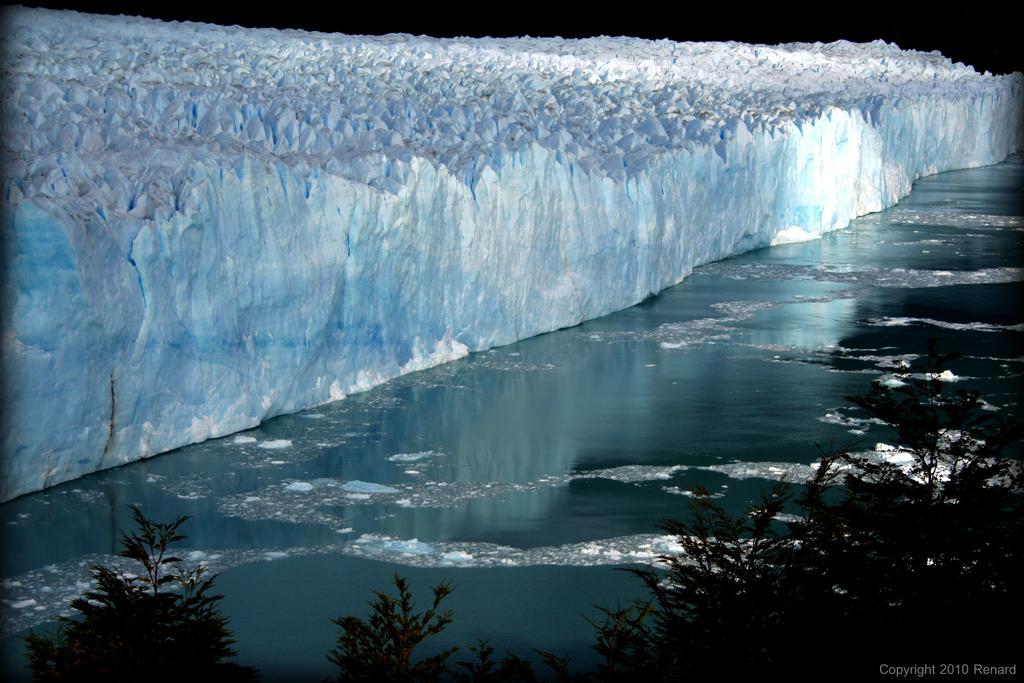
left=8, top=0, right=1024, bottom=73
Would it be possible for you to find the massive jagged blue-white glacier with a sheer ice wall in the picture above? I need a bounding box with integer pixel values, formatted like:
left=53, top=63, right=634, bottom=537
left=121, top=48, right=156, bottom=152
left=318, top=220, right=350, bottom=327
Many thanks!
left=0, top=3, right=1024, bottom=500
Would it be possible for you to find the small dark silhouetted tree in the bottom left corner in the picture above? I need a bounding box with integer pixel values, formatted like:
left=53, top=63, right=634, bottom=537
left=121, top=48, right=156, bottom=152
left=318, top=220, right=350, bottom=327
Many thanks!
left=26, top=507, right=258, bottom=682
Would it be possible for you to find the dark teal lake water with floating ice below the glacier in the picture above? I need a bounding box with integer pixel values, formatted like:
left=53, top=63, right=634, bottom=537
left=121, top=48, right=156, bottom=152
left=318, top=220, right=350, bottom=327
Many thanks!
left=0, top=155, right=1024, bottom=680
